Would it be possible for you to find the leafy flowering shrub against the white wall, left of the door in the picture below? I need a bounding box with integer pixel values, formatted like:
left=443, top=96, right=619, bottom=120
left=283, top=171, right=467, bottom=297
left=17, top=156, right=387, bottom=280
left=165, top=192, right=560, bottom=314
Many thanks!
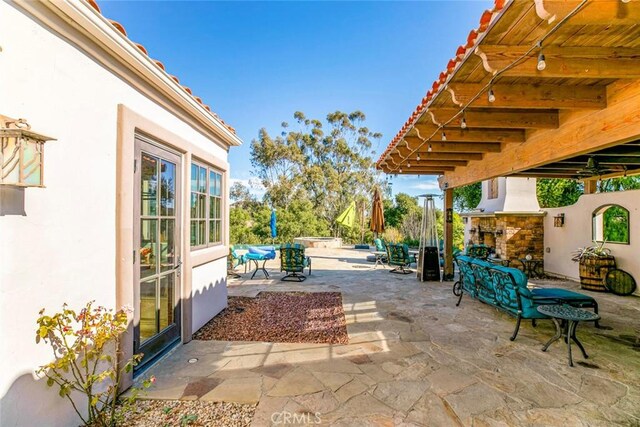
left=36, top=301, right=155, bottom=426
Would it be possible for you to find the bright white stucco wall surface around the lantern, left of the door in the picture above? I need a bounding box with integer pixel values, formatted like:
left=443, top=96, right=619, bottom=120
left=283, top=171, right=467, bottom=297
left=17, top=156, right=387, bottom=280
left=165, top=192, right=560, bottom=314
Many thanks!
left=0, top=2, right=227, bottom=426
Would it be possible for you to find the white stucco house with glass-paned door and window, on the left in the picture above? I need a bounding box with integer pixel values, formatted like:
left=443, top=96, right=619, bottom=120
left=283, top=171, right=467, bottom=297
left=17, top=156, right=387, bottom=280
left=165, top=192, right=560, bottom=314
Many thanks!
left=0, top=0, right=241, bottom=427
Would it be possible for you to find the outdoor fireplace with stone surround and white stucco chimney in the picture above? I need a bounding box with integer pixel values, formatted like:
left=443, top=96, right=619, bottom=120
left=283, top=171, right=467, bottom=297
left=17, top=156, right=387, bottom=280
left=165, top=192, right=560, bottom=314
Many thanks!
left=462, top=178, right=545, bottom=267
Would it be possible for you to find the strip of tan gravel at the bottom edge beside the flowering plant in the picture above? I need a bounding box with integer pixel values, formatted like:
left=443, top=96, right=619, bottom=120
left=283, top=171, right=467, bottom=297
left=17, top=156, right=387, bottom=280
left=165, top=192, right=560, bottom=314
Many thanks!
left=118, top=399, right=256, bottom=427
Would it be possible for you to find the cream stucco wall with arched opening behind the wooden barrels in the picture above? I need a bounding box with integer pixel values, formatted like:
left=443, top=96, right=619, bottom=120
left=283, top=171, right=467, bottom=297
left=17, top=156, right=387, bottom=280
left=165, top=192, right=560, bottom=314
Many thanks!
left=543, top=190, right=640, bottom=295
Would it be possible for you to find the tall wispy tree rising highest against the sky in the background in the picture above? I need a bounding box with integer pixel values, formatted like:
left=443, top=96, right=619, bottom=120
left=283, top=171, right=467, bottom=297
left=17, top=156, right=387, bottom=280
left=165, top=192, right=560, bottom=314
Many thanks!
left=251, top=111, right=385, bottom=234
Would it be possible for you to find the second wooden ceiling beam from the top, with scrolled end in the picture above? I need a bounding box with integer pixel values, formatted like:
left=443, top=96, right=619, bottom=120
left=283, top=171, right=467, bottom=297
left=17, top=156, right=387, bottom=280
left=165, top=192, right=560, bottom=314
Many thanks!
left=475, top=45, right=640, bottom=79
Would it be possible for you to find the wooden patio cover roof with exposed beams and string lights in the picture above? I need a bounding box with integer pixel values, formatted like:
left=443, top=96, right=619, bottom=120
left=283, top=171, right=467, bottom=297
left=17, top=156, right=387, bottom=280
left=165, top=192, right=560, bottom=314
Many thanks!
left=376, top=0, right=640, bottom=188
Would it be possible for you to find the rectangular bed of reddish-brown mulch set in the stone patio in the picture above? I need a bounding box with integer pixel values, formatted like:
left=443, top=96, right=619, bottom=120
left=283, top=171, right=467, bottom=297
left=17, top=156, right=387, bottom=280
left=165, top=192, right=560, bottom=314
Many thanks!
left=193, top=292, right=349, bottom=344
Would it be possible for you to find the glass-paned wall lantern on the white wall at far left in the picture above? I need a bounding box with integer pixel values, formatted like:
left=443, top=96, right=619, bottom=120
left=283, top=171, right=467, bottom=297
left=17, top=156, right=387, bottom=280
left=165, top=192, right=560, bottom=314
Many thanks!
left=0, top=115, right=54, bottom=187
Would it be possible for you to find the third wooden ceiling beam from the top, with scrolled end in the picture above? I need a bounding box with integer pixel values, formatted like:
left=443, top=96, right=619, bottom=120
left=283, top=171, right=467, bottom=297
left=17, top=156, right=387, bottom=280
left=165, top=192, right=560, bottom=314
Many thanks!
left=442, top=83, right=607, bottom=110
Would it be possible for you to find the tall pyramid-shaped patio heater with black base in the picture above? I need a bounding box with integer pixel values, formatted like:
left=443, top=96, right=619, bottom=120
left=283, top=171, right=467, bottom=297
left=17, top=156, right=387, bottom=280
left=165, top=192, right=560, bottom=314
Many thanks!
left=416, top=194, right=441, bottom=282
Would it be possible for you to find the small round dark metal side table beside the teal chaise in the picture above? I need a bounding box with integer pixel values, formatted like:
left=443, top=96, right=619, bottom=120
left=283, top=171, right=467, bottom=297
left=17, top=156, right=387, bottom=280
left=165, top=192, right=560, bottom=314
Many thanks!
left=537, top=304, right=600, bottom=366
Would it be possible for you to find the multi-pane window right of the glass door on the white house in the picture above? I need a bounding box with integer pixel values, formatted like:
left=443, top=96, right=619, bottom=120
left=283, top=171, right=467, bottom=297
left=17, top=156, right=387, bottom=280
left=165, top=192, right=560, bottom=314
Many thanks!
left=191, top=163, right=222, bottom=247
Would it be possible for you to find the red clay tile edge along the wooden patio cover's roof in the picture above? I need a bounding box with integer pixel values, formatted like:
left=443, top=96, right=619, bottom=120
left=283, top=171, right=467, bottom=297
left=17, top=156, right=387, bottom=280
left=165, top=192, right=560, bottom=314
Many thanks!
left=376, top=0, right=507, bottom=167
